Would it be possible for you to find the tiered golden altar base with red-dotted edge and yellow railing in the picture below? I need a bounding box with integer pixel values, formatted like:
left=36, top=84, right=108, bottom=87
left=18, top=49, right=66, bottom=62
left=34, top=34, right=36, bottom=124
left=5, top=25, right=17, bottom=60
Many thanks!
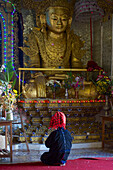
left=18, top=68, right=105, bottom=143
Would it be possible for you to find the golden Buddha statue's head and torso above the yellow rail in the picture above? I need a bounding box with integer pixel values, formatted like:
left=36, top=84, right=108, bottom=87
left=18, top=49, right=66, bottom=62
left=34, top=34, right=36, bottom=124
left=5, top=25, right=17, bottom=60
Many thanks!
left=20, top=0, right=85, bottom=97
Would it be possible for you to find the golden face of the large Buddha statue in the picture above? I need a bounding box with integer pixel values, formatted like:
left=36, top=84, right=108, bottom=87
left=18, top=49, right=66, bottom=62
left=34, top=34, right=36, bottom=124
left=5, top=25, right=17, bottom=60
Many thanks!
left=46, top=7, right=69, bottom=33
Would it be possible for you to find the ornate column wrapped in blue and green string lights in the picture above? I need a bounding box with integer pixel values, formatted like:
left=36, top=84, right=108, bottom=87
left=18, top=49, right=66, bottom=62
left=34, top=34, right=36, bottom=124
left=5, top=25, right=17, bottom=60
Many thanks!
left=0, top=0, right=15, bottom=64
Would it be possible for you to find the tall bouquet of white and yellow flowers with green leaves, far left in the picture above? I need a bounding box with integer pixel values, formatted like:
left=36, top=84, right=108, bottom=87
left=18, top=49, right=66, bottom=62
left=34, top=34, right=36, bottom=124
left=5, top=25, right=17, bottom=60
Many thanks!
left=0, top=62, right=18, bottom=114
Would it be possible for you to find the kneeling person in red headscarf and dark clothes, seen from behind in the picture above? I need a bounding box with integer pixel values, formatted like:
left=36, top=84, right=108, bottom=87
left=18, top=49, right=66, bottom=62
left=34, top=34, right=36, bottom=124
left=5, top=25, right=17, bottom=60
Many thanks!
left=41, top=112, right=72, bottom=165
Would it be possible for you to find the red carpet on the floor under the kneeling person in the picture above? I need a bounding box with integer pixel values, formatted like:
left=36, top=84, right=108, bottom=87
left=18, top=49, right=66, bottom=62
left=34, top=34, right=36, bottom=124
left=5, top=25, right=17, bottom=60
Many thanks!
left=0, top=158, right=113, bottom=170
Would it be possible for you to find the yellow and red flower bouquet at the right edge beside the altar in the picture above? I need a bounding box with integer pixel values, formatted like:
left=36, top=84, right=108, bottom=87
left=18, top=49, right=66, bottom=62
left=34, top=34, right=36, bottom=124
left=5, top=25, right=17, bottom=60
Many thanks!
left=96, top=72, right=113, bottom=95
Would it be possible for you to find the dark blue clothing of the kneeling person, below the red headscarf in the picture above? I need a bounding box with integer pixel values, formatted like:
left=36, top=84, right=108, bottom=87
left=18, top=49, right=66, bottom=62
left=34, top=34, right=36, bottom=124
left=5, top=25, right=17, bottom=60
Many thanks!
left=41, top=127, right=72, bottom=164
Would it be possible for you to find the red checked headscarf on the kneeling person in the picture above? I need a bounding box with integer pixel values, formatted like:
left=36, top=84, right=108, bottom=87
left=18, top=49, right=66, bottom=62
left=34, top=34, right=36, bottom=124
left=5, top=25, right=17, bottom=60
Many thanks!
left=49, top=112, right=66, bottom=129
